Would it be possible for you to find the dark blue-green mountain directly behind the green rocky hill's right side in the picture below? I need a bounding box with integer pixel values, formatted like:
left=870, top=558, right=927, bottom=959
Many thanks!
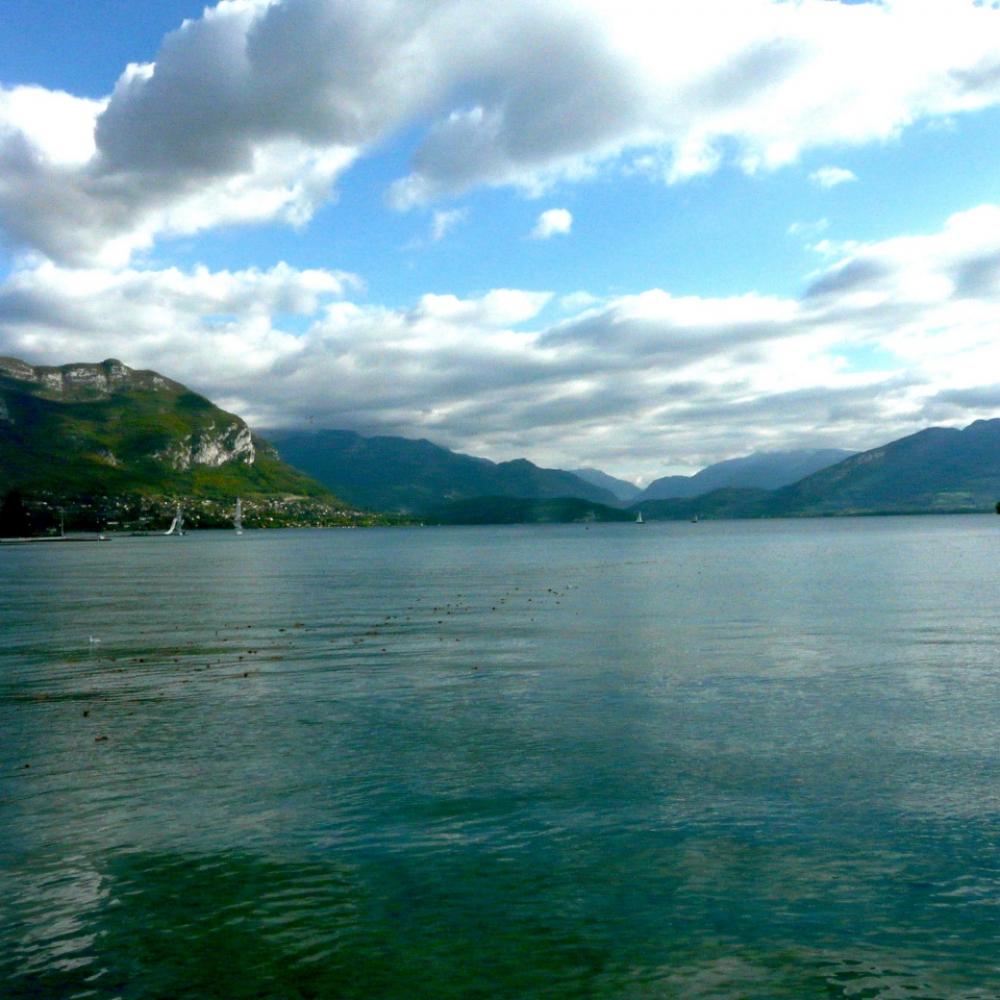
left=267, top=430, right=615, bottom=513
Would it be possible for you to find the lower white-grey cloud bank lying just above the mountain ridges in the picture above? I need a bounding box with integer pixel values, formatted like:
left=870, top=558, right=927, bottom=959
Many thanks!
left=0, top=205, right=1000, bottom=477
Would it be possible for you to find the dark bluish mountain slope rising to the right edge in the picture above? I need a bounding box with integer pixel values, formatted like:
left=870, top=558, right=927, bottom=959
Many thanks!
left=767, top=420, right=1000, bottom=515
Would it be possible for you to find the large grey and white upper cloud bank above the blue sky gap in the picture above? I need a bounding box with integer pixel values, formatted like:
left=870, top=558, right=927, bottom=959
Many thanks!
left=0, top=0, right=1000, bottom=266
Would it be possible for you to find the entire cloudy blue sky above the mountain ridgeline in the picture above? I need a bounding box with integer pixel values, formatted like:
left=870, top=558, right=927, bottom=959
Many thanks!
left=0, top=0, right=1000, bottom=482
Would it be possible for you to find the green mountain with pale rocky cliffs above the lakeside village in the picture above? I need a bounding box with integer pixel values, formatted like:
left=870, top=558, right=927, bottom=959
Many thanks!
left=0, top=358, right=333, bottom=499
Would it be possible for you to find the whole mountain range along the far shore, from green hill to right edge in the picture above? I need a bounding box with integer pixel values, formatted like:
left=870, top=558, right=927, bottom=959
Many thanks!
left=0, top=358, right=1000, bottom=523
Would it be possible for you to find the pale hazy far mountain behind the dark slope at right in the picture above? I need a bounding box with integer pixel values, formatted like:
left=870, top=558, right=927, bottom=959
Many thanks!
left=638, top=448, right=854, bottom=501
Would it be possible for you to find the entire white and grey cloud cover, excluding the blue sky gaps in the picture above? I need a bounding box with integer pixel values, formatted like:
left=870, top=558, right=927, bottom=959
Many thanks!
left=0, top=0, right=1000, bottom=474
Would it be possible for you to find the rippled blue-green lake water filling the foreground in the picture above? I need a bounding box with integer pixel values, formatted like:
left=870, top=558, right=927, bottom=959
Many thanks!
left=0, top=516, right=1000, bottom=1000
